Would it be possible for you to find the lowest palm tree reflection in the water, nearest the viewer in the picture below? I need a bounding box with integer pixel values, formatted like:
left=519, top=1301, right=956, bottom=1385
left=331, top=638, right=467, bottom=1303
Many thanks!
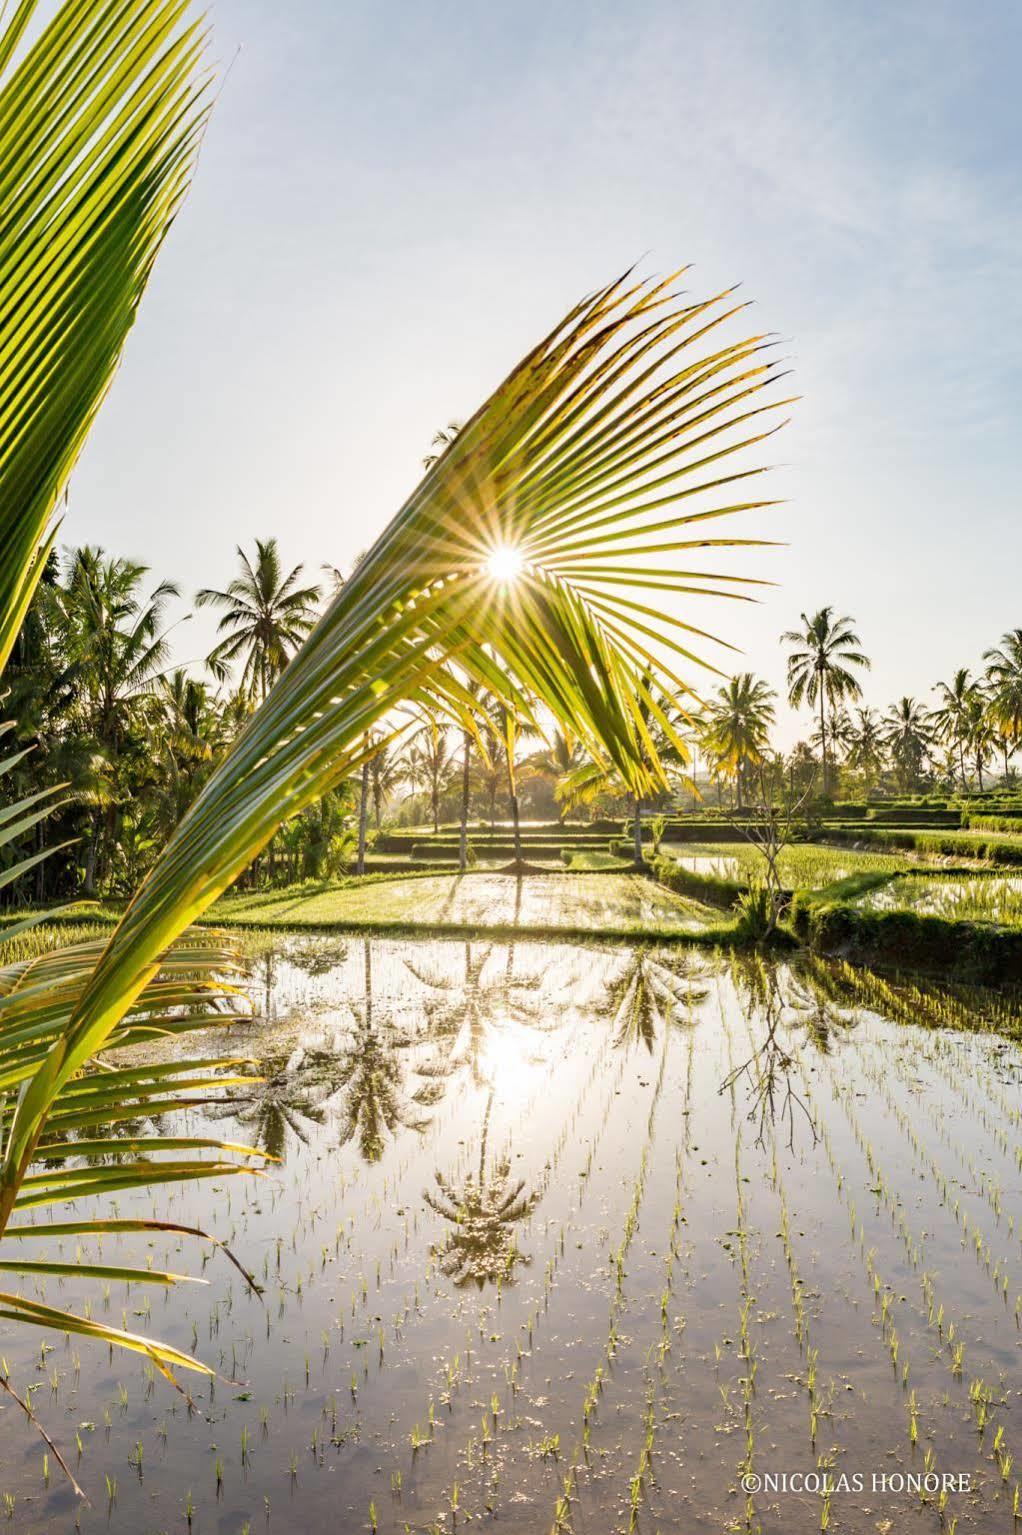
left=424, top=1085, right=539, bottom=1289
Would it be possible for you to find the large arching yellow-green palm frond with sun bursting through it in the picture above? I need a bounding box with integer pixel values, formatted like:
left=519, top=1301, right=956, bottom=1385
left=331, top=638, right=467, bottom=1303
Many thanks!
left=0, top=270, right=775, bottom=1197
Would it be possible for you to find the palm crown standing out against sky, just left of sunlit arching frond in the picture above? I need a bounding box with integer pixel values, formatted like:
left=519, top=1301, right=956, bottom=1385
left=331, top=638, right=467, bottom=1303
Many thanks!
left=195, top=539, right=322, bottom=700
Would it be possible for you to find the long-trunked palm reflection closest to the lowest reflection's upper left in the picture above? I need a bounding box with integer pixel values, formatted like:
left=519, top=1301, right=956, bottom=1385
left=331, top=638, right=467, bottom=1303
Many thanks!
left=339, top=938, right=428, bottom=1162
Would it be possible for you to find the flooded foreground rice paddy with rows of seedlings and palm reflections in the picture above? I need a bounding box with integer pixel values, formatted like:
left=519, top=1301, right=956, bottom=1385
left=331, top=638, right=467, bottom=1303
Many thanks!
left=0, top=935, right=1022, bottom=1535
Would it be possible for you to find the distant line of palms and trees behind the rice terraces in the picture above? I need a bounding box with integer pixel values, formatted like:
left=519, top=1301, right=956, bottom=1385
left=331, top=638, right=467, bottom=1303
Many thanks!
left=0, top=539, right=1022, bottom=901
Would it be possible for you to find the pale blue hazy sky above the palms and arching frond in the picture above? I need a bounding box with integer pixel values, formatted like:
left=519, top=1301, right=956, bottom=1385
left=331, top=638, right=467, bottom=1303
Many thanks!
left=64, top=0, right=1022, bottom=741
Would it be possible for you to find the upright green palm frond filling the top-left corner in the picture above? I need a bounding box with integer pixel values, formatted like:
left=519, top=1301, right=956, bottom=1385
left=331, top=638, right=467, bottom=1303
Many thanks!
left=0, top=0, right=207, bottom=671
